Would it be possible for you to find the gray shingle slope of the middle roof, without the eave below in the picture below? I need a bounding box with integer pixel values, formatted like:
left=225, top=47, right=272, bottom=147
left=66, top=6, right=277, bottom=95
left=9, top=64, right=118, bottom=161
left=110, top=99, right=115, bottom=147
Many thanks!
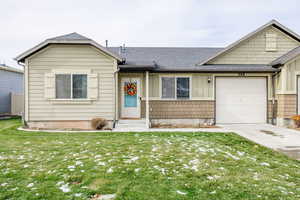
left=108, top=47, right=222, bottom=68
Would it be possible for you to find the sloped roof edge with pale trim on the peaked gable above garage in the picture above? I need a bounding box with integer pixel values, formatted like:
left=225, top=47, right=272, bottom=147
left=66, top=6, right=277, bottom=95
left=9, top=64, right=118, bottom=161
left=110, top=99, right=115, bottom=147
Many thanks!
left=198, top=20, right=300, bottom=65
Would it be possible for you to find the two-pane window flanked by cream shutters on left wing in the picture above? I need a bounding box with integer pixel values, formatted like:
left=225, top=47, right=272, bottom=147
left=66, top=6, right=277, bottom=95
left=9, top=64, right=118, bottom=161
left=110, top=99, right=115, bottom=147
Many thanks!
left=55, top=74, right=87, bottom=99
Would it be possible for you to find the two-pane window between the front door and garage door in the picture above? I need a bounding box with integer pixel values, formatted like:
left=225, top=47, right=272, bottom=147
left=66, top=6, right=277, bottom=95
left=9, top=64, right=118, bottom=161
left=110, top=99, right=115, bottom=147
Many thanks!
left=161, top=77, right=190, bottom=99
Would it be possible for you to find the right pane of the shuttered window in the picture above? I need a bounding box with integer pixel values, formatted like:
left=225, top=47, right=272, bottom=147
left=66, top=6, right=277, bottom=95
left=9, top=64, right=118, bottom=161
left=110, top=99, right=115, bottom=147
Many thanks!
left=73, top=74, right=87, bottom=99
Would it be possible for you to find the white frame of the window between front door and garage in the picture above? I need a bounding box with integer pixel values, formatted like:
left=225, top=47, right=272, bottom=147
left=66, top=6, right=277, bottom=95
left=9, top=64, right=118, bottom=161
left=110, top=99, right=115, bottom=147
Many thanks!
left=159, top=75, right=192, bottom=101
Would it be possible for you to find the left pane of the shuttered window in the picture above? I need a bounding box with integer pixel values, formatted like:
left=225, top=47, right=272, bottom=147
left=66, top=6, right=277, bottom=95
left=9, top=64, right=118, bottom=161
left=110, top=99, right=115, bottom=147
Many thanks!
left=55, top=74, right=71, bottom=99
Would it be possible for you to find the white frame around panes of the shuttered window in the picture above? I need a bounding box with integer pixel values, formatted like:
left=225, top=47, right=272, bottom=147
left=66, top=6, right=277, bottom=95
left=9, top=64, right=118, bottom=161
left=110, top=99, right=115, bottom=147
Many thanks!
left=52, top=71, right=90, bottom=101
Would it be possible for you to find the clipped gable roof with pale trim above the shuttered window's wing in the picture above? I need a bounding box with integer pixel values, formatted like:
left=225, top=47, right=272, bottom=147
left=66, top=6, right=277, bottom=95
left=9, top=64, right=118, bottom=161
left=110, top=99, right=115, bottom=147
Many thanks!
left=15, top=32, right=122, bottom=63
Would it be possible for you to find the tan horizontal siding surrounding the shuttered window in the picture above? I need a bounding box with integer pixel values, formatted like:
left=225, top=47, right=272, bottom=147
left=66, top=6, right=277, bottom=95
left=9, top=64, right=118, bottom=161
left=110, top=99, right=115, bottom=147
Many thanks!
left=28, top=45, right=115, bottom=121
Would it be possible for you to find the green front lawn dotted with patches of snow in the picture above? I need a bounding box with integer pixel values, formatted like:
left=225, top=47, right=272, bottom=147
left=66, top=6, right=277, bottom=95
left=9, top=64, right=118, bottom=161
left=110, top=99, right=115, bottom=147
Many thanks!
left=0, top=119, right=300, bottom=200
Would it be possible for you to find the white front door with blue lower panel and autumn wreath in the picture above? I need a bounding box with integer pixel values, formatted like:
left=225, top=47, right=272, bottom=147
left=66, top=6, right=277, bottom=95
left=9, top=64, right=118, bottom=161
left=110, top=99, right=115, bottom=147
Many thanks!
left=121, top=78, right=141, bottom=118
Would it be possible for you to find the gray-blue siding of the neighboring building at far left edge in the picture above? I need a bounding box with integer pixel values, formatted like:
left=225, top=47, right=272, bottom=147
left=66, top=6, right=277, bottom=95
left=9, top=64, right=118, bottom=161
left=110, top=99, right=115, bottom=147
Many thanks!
left=0, top=69, right=23, bottom=113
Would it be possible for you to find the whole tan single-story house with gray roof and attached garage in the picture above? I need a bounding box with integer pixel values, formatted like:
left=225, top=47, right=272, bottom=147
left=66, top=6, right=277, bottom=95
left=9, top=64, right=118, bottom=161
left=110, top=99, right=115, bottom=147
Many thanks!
left=16, top=20, right=300, bottom=129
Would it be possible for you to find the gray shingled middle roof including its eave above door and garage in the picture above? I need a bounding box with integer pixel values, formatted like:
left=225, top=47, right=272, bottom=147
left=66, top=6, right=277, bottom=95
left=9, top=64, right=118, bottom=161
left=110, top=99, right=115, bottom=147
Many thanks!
left=108, top=47, right=278, bottom=72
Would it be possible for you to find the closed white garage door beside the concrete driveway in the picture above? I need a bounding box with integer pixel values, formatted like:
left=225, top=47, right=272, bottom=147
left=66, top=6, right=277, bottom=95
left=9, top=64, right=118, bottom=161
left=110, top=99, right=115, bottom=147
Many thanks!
left=216, top=77, right=267, bottom=124
